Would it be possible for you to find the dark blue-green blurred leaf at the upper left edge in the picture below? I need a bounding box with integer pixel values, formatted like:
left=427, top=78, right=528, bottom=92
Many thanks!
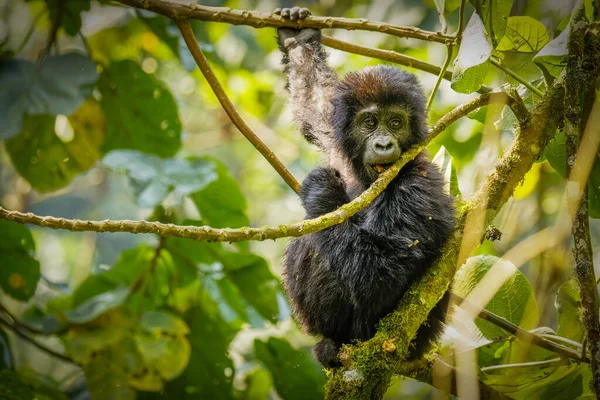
left=0, top=53, right=98, bottom=140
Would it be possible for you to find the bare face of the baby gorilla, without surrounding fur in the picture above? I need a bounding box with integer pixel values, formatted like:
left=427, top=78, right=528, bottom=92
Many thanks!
left=353, top=105, right=410, bottom=180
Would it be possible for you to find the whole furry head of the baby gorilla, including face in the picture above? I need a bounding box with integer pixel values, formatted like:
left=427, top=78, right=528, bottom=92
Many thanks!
left=331, top=65, right=427, bottom=187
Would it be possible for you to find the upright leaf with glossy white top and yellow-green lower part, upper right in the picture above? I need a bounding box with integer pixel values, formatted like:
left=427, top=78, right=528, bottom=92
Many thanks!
left=450, top=13, right=493, bottom=93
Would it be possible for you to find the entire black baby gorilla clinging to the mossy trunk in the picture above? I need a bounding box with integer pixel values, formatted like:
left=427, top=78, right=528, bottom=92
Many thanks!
left=275, top=7, right=455, bottom=367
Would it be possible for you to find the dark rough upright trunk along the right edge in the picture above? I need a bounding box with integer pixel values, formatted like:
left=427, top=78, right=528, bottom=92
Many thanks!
left=564, top=20, right=600, bottom=399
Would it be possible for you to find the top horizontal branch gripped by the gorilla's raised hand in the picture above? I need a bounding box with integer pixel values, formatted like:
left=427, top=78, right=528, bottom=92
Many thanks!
left=117, top=0, right=454, bottom=44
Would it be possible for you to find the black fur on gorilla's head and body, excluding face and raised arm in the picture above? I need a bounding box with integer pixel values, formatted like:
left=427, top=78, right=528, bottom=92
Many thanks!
left=276, top=10, right=455, bottom=367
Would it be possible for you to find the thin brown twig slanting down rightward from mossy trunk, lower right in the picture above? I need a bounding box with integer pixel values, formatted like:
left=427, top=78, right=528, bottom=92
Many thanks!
left=452, top=293, right=589, bottom=362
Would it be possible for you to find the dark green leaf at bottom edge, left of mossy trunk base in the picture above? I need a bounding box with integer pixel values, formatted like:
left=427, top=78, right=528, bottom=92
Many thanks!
left=254, top=337, right=325, bottom=400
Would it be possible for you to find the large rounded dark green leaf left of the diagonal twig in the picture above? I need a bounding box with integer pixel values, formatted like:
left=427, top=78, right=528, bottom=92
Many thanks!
left=98, top=60, right=181, bottom=157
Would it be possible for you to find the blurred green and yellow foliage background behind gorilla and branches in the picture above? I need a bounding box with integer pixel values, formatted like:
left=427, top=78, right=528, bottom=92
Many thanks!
left=0, top=0, right=600, bottom=400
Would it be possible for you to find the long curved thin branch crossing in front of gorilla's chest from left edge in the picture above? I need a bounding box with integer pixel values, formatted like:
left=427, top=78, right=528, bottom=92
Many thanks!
left=0, top=92, right=511, bottom=242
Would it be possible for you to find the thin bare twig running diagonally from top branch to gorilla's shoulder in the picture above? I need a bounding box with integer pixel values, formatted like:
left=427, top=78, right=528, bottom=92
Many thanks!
left=175, top=19, right=300, bottom=193
